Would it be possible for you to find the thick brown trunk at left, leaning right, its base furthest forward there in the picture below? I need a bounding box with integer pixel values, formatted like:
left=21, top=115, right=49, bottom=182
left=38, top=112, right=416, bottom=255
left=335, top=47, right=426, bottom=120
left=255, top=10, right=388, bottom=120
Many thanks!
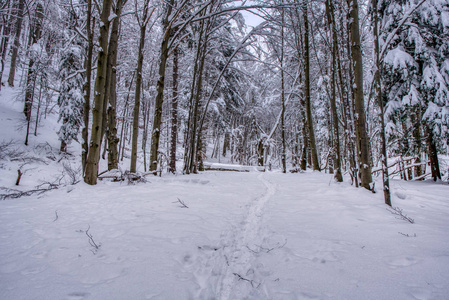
left=84, top=0, right=112, bottom=185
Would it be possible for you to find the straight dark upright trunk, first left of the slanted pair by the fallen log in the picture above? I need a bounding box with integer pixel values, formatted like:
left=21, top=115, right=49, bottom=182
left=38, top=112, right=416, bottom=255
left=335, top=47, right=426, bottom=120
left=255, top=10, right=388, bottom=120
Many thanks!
left=170, top=48, right=178, bottom=173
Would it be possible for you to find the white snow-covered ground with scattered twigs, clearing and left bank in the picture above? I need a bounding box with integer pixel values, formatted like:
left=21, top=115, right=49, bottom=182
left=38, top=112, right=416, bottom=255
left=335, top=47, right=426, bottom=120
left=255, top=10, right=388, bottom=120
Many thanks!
left=0, top=77, right=449, bottom=300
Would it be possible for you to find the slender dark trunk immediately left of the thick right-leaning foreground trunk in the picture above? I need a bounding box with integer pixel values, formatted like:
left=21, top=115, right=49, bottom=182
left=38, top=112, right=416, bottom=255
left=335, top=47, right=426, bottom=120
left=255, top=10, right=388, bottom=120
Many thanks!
left=81, top=0, right=95, bottom=175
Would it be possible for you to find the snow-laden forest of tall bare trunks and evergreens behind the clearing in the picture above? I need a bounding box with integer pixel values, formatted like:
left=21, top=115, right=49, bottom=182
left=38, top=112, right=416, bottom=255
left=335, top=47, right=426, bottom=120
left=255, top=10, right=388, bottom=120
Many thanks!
left=0, top=0, right=449, bottom=197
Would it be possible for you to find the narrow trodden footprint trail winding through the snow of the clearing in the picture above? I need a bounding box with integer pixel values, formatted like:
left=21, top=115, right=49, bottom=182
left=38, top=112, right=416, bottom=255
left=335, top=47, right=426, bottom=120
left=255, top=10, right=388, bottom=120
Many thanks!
left=187, top=173, right=276, bottom=300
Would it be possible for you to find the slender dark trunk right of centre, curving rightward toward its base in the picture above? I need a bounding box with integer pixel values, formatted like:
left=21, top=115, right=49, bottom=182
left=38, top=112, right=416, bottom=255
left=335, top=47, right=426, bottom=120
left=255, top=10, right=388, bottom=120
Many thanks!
left=303, top=0, right=320, bottom=171
